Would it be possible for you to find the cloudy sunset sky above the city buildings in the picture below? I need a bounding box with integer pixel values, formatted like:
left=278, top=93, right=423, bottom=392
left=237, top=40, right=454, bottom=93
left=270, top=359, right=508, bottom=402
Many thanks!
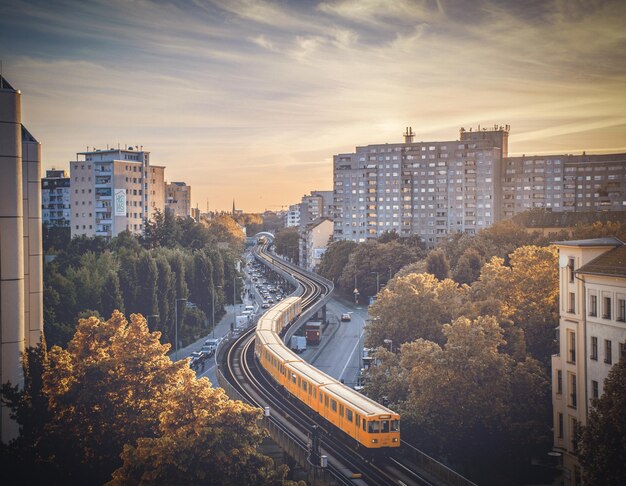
left=0, top=0, right=626, bottom=212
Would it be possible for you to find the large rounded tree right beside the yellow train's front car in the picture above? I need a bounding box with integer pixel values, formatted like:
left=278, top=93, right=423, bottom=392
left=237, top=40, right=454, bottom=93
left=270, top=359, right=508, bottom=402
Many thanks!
left=366, top=316, right=551, bottom=479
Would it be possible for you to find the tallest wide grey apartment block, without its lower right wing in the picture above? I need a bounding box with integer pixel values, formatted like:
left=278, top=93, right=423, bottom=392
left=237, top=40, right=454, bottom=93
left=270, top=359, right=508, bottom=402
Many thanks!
left=333, top=126, right=502, bottom=246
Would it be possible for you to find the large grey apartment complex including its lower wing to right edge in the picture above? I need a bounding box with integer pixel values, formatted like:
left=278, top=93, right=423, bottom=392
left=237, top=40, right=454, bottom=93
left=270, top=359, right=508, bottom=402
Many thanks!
left=332, top=125, right=626, bottom=247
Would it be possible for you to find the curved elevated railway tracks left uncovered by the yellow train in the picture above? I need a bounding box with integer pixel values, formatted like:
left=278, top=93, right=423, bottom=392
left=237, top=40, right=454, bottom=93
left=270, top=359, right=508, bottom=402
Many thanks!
left=222, top=247, right=432, bottom=485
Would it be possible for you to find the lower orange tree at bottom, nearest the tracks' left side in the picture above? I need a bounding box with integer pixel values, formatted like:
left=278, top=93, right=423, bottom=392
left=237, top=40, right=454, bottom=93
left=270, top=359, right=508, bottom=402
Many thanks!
left=109, top=373, right=294, bottom=485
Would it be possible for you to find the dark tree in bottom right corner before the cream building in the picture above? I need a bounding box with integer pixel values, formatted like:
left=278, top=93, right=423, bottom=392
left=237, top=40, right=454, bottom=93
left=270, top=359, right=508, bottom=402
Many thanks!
left=578, top=357, right=626, bottom=486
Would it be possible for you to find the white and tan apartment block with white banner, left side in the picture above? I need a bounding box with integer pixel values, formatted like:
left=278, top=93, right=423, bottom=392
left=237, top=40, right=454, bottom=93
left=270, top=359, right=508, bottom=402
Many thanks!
left=70, top=147, right=164, bottom=238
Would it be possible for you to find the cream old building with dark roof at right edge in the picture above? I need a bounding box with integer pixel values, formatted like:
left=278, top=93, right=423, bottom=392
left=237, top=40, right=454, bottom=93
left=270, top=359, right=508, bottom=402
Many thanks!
left=552, top=238, right=626, bottom=486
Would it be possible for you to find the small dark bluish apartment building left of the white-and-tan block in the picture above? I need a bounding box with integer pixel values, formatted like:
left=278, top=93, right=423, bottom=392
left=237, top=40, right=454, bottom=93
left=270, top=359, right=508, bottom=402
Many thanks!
left=41, top=169, right=71, bottom=228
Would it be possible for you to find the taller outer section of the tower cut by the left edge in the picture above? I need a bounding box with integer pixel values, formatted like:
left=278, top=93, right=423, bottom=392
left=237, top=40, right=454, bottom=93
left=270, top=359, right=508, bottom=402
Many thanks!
left=0, top=82, right=24, bottom=443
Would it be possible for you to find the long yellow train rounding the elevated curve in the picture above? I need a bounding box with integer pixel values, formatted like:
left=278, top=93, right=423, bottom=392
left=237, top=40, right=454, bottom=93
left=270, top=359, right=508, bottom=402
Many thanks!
left=255, top=297, right=400, bottom=449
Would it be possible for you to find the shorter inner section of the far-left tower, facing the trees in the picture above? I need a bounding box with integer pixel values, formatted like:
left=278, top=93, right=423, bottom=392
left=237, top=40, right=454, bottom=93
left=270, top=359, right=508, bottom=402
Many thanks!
left=22, top=131, right=43, bottom=347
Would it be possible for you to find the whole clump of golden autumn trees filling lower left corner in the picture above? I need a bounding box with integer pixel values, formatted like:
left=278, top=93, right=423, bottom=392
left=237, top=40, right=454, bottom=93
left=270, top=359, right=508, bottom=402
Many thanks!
left=3, top=312, right=292, bottom=484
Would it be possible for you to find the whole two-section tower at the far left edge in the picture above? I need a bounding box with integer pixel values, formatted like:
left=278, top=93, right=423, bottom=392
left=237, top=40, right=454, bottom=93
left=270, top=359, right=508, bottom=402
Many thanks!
left=0, top=76, right=43, bottom=443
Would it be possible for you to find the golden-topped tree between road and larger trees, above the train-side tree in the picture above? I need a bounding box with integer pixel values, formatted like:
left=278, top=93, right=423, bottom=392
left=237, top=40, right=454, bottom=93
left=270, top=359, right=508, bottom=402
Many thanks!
left=366, top=273, right=473, bottom=348
